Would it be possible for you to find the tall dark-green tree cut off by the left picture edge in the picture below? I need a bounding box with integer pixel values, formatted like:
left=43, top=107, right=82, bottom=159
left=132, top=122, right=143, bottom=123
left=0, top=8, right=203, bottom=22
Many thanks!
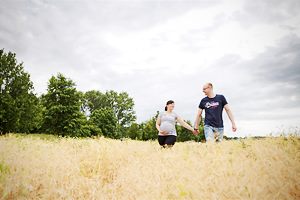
left=0, top=49, right=40, bottom=133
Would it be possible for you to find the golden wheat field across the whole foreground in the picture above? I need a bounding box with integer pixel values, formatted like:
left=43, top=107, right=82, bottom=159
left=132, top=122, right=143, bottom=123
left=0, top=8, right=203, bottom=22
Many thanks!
left=0, top=134, right=300, bottom=200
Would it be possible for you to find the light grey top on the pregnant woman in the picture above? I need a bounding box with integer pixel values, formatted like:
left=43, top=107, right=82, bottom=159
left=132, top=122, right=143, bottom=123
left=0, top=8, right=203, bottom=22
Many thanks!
left=158, top=112, right=178, bottom=136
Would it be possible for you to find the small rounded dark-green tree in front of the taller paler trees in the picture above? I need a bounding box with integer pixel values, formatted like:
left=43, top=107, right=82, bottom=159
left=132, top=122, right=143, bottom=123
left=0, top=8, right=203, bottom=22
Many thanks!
left=90, top=107, right=120, bottom=139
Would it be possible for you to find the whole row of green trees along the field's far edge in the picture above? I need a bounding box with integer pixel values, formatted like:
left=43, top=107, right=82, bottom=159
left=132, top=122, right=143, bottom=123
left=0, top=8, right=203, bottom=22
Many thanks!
left=0, top=49, right=204, bottom=141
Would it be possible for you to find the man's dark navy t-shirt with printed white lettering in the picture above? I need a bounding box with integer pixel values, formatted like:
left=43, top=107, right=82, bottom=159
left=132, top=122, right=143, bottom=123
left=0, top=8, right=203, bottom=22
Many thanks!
left=199, top=94, right=227, bottom=128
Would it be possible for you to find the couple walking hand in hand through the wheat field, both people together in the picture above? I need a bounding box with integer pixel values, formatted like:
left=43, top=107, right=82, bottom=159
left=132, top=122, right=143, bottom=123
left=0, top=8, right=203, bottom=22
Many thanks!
left=156, top=83, right=236, bottom=147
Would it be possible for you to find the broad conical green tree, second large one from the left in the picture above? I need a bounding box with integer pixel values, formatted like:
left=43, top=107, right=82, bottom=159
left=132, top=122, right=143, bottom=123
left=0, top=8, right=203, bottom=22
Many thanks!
left=42, top=73, right=91, bottom=136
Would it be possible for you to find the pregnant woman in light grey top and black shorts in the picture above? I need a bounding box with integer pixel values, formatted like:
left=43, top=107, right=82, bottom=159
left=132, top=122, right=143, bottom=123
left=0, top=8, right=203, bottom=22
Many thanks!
left=156, top=100, right=194, bottom=148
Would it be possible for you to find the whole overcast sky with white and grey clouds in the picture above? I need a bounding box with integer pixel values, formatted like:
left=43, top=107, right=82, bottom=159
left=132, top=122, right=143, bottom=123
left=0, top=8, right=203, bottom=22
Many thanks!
left=0, top=0, right=300, bottom=136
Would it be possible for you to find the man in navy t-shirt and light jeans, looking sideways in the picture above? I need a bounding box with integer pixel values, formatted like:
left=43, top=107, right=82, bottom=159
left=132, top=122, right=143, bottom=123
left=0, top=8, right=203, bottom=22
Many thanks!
left=194, top=83, right=236, bottom=142
